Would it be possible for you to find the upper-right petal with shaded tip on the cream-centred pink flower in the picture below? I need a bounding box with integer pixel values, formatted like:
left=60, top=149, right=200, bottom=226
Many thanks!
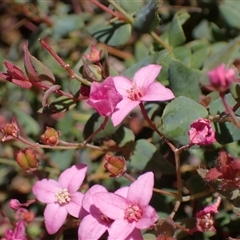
left=58, top=164, right=87, bottom=193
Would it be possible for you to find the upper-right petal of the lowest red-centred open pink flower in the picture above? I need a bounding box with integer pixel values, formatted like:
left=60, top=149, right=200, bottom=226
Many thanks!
left=128, top=172, right=154, bottom=206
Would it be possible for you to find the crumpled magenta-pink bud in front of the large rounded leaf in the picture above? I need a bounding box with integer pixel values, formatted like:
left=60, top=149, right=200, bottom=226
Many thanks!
left=188, top=118, right=216, bottom=146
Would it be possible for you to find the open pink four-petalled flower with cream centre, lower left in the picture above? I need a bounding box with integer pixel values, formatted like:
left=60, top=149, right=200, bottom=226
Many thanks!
left=33, top=164, right=87, bottom=234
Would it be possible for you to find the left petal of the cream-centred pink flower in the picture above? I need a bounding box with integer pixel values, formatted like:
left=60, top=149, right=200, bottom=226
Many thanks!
left=32, top=179, right=61, bottom=203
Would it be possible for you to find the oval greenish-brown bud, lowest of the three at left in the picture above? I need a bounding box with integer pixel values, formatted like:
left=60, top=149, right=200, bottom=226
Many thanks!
left=16, top=148, right=39, bottom=172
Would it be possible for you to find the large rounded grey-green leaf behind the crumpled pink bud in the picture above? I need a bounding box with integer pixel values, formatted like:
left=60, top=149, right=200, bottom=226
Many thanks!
left=159, top=96, right=208, bottom=145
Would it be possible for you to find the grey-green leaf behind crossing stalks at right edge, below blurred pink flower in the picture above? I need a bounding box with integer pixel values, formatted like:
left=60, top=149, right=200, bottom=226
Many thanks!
left=210, top=93, right=240, bottom=144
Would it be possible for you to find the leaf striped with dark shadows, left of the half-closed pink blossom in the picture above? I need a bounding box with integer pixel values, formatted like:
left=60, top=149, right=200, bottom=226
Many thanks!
left=38, top=96, right=76, bottom=114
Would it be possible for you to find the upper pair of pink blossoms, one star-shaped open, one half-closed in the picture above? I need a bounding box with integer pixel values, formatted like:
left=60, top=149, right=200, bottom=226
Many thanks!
left=87, top=64, right=174, bottom=126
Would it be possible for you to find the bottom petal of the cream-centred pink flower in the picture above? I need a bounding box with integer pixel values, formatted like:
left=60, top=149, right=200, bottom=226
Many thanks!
left=43, top=203, right=67, bottom=234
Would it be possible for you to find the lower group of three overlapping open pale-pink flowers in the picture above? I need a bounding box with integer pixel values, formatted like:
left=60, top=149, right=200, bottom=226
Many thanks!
left=33, top=164, right=158, bottom=240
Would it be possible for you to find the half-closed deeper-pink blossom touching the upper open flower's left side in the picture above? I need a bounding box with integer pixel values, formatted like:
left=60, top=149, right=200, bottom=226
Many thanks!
left=87, top=77, right=122, bottom=117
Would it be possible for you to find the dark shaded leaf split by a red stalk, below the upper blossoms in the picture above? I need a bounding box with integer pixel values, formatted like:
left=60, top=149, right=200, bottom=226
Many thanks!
left=83, top=112, right=120, bottom=141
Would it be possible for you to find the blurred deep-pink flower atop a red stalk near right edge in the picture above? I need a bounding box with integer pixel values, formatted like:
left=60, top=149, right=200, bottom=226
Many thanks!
left=208, top=64, right=236, bottom=93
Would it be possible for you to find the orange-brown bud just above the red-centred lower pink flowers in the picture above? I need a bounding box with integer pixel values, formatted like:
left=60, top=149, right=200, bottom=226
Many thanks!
left=104, top=154, right=127, bottom=177
